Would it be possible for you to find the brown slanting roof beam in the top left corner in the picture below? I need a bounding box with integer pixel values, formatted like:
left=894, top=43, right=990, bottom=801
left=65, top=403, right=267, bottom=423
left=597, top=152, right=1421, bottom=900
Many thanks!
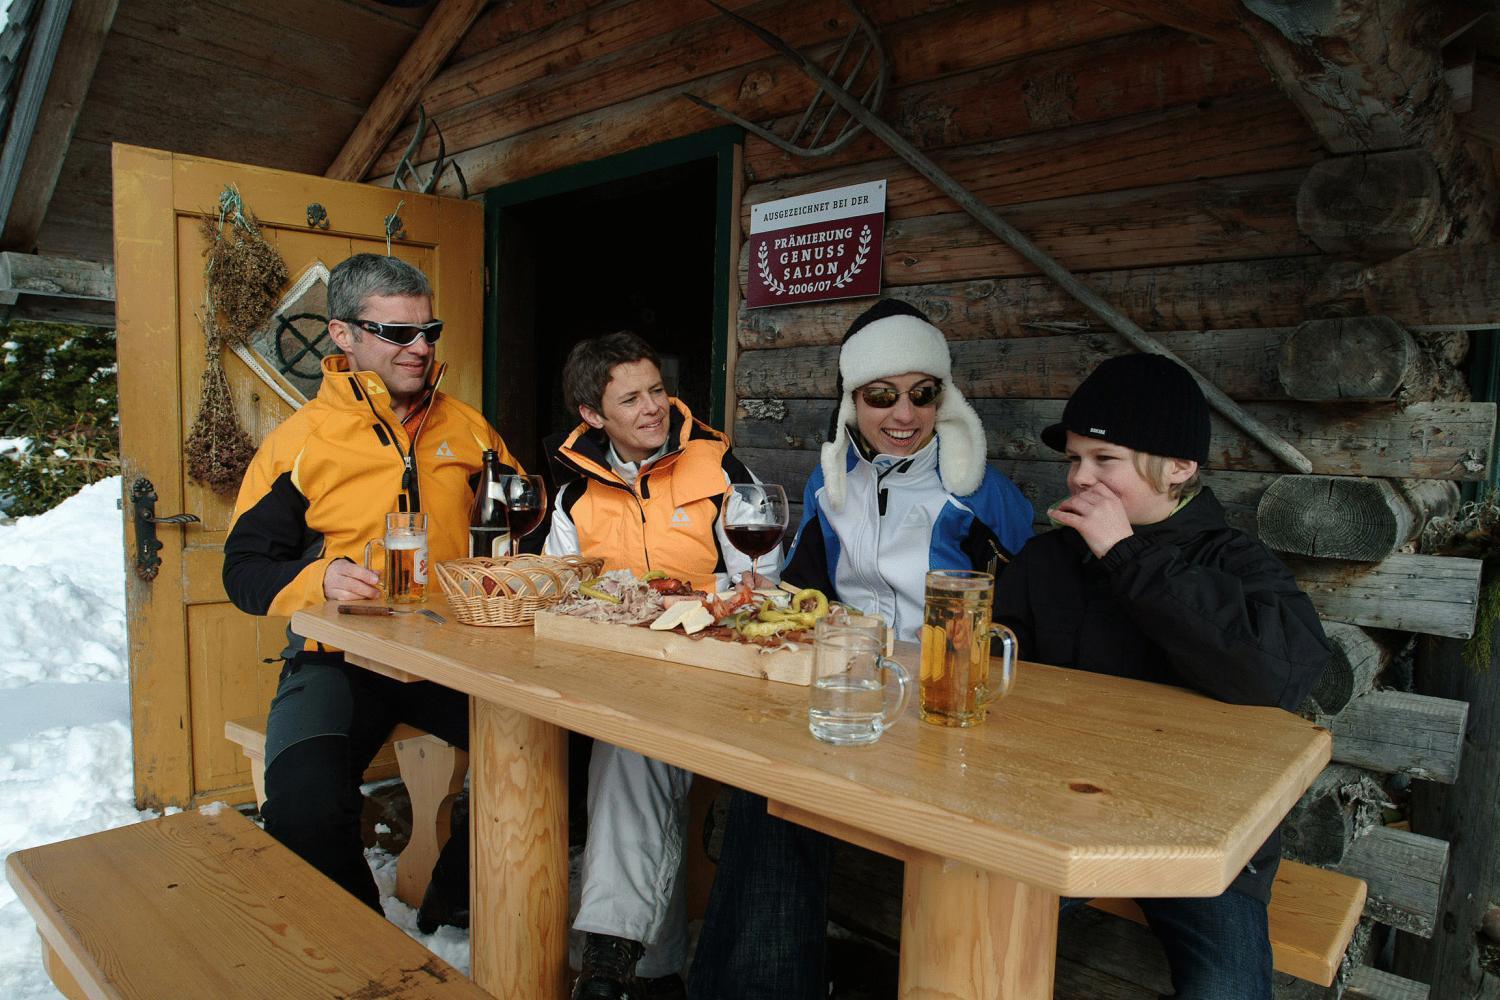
left=0, top=0, right=119, bottom=253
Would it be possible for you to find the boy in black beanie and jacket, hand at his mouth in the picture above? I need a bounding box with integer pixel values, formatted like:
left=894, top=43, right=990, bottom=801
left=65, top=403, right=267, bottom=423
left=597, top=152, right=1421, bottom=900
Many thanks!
left=995, top=354, right=1329, bottom=1000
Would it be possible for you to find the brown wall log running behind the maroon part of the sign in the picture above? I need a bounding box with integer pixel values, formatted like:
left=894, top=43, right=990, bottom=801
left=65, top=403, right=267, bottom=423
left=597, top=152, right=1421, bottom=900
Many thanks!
left=740, top=171, right=1314, bottom=288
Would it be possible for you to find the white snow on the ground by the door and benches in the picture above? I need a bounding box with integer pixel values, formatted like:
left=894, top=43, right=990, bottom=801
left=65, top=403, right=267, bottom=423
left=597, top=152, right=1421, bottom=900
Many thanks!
left=0, top=476, right=468, bottom=1000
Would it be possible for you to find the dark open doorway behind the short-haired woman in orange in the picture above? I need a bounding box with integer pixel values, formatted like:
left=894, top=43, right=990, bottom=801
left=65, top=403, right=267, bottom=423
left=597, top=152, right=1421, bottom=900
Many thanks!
left=486, top=127, right=732, bottom=471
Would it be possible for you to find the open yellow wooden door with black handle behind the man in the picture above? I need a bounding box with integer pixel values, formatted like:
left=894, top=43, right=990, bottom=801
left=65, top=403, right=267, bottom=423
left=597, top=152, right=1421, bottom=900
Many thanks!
left=114, top=145, right=485, bottom=808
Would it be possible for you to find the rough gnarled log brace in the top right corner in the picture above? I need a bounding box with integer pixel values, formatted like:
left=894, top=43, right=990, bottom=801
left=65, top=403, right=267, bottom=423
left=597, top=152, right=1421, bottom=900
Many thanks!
left=1242, top=0, right=1496, bottom=246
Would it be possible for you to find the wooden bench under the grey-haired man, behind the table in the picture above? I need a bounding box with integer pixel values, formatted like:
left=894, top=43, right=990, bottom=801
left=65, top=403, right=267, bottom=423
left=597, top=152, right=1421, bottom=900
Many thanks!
left=224, top=715, right=468, bottom=909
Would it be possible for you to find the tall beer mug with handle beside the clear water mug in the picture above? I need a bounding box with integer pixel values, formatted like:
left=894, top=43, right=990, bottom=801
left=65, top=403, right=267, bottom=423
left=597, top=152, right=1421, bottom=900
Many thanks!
left=918, top=570, right=1017, bottom=729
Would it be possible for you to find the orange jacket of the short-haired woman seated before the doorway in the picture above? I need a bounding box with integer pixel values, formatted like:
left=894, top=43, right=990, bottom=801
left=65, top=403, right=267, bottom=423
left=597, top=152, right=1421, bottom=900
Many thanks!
left=557, top=397, right=752, bottom=591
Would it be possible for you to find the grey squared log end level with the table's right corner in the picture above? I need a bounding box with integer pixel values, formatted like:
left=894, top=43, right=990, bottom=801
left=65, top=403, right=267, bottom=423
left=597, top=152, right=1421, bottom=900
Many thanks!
left=1317, top=691, right=1469, bottom=784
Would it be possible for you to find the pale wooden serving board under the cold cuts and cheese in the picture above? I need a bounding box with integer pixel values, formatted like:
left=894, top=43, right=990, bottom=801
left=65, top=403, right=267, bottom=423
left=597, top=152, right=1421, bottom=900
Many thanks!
left=537, top=610, right=813, bottom=687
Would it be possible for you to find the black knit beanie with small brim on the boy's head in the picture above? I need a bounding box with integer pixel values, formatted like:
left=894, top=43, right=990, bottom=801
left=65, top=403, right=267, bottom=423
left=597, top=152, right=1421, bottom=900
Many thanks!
left=1041, top=354, right=1209, bottom=463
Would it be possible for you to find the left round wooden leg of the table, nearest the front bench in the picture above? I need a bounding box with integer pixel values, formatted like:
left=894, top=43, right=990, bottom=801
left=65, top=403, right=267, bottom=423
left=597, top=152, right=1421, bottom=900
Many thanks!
left=470, top=699, right=569, bottom=1000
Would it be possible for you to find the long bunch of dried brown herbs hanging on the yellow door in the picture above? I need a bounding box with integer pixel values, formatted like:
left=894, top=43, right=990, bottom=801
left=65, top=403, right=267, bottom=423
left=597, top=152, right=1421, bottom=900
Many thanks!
left=186, top=184, right=288, bottom=496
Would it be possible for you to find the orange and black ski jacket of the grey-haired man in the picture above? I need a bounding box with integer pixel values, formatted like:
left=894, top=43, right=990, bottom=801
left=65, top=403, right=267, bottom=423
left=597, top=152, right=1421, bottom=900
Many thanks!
left=224, top=354, right=519, bottom=644
